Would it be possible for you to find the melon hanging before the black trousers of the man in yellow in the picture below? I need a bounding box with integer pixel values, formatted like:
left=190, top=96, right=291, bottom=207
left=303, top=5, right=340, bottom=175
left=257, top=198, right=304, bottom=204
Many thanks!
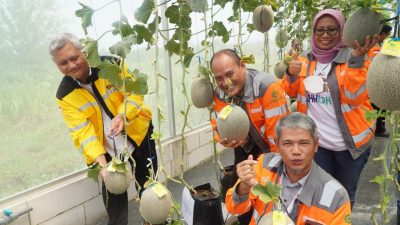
left=104, top=170, right=131, bottom=195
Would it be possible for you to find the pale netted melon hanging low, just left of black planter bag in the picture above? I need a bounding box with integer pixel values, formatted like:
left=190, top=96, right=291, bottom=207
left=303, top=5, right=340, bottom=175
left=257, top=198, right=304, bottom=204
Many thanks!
left=139, top=183, right=173, bottom=224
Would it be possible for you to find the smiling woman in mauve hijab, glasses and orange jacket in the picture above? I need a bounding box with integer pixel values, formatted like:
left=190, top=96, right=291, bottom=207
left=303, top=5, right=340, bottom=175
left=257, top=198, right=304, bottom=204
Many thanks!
left=283, top=9, right=376, bottom=206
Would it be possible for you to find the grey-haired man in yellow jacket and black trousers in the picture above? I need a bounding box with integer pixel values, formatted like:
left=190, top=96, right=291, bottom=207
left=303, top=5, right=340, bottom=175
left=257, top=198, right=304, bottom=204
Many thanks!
left=49, top=33, right=157, bottom=225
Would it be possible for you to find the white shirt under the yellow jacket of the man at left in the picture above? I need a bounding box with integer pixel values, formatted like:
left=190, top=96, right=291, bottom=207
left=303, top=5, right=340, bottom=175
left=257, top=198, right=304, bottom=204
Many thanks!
left=78, top=81, right=135, bottom=156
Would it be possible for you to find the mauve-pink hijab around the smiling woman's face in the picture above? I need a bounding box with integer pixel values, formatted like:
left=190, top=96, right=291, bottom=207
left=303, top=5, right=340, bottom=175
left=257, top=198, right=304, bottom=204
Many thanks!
left=311, top=9, right=345, bottom=63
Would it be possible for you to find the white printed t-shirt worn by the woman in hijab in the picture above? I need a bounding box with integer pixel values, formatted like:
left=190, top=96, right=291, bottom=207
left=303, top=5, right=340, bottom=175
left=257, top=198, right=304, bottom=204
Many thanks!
left=307, top=62, right=347, bottom=151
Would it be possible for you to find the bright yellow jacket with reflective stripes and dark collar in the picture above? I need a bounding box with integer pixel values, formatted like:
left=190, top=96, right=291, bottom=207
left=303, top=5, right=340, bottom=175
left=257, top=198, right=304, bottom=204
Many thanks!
left=56, top=68, right=151, bottom=165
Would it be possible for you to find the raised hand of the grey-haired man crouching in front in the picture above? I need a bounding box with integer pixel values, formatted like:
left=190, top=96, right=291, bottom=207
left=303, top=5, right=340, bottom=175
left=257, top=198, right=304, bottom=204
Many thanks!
left=236, top=155, right=257, bottom=196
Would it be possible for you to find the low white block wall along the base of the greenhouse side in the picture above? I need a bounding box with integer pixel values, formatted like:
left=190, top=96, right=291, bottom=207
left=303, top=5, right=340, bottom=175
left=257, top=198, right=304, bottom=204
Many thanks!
left=0, top=124, right=223, bottom=225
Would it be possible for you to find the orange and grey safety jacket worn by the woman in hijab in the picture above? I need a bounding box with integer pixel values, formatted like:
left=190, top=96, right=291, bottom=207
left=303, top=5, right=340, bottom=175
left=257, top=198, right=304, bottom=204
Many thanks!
left=282, top=48, right=375, bottom=159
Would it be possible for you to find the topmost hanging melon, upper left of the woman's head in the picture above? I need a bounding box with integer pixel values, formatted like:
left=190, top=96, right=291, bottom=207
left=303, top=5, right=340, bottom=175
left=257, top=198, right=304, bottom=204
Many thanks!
left=253, top=5, right=274, bottom=33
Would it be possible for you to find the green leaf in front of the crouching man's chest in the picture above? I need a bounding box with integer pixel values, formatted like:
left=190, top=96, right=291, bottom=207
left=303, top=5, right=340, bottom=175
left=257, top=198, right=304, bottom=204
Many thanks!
left=251, top=181, right=282, bottom=203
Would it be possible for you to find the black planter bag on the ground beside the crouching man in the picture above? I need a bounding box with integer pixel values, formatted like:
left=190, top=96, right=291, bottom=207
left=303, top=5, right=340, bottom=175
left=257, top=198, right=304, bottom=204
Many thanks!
left=192, top=183, right=224, bottom=225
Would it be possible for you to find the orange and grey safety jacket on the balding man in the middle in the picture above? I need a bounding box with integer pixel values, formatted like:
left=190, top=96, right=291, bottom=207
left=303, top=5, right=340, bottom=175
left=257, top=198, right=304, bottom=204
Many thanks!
left=211, top=69, right=289, bottom=152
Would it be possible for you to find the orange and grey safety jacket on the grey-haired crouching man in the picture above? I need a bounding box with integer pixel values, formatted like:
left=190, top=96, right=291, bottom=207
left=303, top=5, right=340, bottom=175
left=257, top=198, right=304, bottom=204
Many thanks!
left=225, top=153, right=351, bottom=225
